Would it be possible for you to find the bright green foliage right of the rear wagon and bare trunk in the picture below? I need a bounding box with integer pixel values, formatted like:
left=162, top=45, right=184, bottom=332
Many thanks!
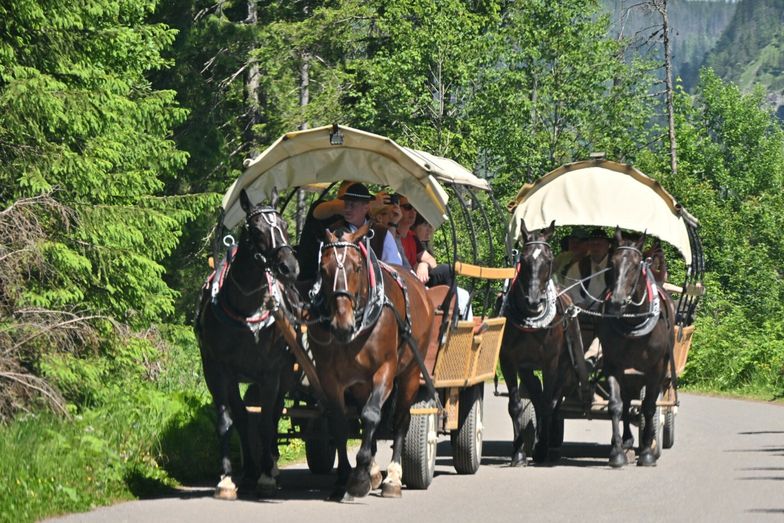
left=641, top=70, right=784, bottom=395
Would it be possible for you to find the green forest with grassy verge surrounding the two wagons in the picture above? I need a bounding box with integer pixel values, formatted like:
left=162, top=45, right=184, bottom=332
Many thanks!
left=0, top=0, right=784, bottom=521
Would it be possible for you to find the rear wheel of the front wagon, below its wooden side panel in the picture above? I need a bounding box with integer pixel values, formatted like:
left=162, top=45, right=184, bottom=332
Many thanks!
left=452, top=383, right=484, bottom=474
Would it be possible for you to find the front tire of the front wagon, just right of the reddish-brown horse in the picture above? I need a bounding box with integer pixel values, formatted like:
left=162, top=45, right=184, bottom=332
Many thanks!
left=402, top=399, right=438, bottom=490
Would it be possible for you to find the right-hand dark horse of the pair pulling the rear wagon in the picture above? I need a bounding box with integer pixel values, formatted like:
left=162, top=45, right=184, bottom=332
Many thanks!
left=598, top=228, right=675, bottom=467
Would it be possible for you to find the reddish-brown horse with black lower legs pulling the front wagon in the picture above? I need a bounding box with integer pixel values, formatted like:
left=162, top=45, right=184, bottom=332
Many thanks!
left=308, top=224, right=433, bottom=500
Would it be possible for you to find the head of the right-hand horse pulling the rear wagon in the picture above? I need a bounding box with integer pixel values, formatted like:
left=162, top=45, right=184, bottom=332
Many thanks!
left=605, top=227, right=645, bottom=315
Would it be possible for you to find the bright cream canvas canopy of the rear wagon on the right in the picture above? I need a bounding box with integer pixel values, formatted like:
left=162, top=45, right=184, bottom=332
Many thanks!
left=507, top=160, right=697, bottom=264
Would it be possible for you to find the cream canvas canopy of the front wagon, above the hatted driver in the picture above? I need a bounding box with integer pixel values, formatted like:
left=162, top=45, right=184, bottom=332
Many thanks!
left=222, top=125, right=490, bottom=228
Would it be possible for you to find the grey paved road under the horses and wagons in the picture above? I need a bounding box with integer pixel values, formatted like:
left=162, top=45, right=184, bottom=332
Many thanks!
left=49, top=390, right=784, bottom=523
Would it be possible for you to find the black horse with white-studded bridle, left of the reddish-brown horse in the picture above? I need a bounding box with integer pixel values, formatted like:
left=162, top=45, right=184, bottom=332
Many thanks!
left=195, top=190, right=299, bottom=499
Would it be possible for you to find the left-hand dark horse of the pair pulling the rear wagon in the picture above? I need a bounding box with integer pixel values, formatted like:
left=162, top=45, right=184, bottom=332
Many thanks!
left=500, top=221, right=591, bottom=467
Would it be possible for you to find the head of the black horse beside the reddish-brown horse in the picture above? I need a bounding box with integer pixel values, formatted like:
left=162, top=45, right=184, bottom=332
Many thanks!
left=240, top=189, right=299, bottom=283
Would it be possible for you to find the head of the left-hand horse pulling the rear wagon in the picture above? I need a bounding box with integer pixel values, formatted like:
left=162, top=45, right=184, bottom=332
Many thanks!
left=517, top=220, right=555, bottom=312
